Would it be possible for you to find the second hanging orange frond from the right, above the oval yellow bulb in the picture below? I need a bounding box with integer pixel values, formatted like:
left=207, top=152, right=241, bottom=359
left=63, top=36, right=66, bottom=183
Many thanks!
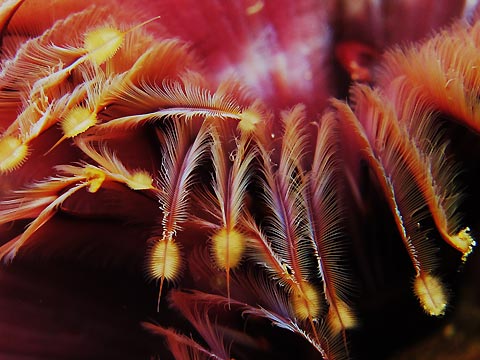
left=352, top=86, right=447, bottom=315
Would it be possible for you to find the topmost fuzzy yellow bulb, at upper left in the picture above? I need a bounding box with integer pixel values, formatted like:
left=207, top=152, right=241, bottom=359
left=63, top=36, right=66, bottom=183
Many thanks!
left=83, top=27, right=125, bottom=65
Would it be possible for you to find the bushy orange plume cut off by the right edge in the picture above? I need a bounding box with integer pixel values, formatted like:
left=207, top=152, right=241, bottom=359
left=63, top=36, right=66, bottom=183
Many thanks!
left=377, top=22, right=480, bottom=132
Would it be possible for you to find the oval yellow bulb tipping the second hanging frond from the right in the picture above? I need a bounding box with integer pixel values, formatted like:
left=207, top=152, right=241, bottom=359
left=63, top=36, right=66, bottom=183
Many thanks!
left=413, top=274, right=448, bottom=316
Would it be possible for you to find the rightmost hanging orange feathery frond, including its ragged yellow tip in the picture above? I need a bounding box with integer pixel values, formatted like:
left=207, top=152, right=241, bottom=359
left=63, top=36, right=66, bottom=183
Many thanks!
left=385, top=79, right=475, bottom=260
